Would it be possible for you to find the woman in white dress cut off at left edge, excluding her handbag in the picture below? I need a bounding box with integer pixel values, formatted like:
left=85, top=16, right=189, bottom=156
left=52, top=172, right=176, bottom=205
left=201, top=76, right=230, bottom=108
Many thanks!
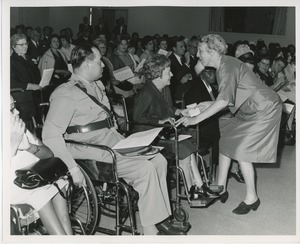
left=10, top=96, right=73, bottom=235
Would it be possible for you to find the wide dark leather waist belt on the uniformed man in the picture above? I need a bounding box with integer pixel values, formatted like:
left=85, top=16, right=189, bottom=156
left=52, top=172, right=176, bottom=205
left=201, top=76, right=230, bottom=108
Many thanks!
left=66, top=118, right=114, bottom=134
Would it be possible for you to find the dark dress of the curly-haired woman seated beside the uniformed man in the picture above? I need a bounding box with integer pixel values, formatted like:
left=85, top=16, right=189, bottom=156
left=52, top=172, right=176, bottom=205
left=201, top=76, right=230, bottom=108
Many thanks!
left=133, top=82, right=197, bottom=159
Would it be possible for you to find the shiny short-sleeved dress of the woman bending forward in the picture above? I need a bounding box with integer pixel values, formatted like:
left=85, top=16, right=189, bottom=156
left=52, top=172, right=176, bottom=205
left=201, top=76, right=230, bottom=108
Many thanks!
left=216, top=56, right=282, bottom=163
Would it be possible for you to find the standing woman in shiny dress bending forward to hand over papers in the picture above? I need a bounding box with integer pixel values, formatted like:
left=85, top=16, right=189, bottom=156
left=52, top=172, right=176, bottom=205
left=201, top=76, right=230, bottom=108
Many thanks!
left=176, top=34, right=282, bottom=214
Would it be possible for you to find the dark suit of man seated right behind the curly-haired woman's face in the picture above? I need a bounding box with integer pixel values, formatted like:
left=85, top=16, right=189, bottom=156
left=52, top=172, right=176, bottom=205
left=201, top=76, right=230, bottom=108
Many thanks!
left=169, top=53, right=192, bottom=102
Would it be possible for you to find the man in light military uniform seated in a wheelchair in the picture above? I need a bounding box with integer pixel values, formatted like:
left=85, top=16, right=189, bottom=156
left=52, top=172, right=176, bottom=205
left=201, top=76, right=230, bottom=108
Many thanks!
left=42, top=44, right=187, bottom=235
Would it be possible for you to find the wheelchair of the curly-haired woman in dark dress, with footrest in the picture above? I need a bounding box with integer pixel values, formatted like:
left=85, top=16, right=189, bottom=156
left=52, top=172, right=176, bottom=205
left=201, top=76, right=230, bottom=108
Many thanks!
left=112, top=97, right=221, bottom=225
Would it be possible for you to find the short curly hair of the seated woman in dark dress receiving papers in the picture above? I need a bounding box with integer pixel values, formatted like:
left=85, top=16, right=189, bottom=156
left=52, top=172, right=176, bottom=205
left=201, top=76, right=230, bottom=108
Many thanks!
left=141, top=54, right=171, bottom=82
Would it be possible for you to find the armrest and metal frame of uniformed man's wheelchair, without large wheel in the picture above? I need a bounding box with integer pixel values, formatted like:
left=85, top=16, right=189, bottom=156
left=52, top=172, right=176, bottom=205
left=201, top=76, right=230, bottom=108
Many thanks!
left=66, top=140, right=140, bottom=235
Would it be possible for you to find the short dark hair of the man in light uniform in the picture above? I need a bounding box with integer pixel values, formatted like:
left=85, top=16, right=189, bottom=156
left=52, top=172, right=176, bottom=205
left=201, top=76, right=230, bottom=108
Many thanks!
left=71, top=43, right=98, bottom=69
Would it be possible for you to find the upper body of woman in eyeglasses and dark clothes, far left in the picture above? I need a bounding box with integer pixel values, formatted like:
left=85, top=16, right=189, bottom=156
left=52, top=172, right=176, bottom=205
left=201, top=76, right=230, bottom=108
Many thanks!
left=10, top=34, right=42, bottom=90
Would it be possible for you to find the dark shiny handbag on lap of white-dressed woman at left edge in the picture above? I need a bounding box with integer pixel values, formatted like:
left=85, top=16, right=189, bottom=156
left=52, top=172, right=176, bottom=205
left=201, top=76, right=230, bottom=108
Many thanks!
left=14, top=157, right=68, bottom=191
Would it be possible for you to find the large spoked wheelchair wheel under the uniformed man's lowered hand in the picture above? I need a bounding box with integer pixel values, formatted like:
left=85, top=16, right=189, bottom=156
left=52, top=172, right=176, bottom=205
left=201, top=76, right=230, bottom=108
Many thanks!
left=70, top=168, right=99, bottom=235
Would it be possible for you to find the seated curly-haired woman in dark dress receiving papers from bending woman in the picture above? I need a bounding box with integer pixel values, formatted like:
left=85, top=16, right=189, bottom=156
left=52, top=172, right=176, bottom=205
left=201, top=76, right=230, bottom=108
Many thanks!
left=133, top=55, right=218, bottom=198
